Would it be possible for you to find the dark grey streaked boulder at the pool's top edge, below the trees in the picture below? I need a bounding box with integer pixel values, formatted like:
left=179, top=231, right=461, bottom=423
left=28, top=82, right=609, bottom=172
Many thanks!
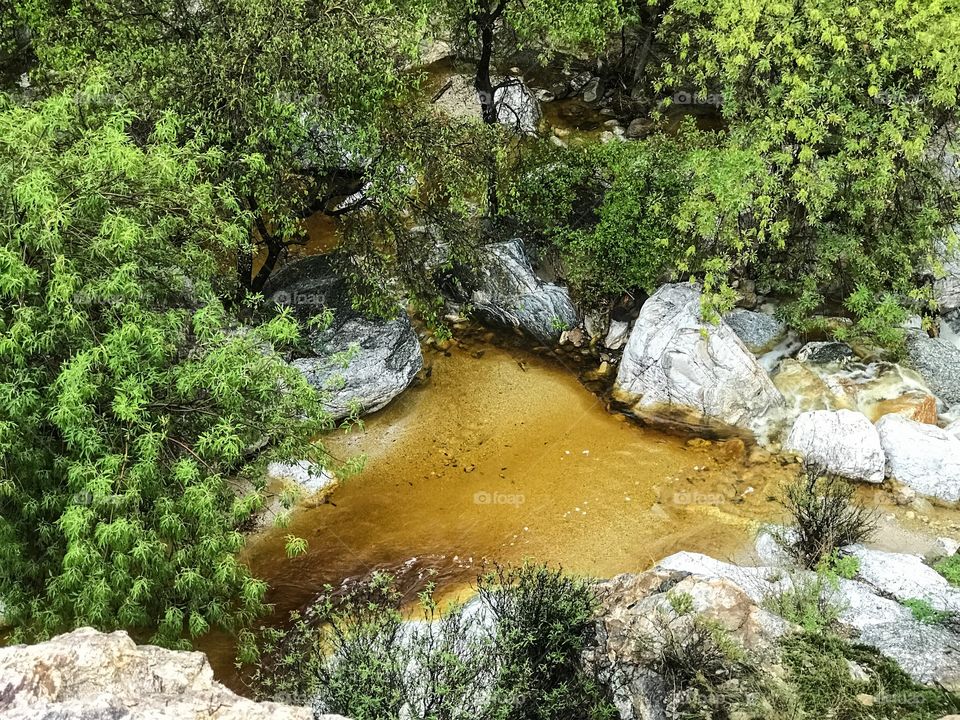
left=470, top=239, right=579, bottom=343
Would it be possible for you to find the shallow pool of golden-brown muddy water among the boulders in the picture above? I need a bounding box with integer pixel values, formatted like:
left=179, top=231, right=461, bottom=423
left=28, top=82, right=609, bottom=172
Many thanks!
left=201, top=342, right=793, bottom=687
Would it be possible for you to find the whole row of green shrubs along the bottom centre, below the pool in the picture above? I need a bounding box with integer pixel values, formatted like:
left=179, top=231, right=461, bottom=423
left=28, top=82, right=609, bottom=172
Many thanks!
left=248, top=565, right=615, bottom=720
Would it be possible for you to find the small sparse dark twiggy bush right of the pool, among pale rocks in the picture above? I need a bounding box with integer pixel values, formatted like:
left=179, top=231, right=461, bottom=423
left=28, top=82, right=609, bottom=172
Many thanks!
left=774, top=467, right=876, bottom=568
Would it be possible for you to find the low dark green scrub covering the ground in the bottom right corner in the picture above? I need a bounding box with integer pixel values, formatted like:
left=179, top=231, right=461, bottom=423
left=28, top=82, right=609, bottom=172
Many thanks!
left=782, top=634, right=960, bottom=720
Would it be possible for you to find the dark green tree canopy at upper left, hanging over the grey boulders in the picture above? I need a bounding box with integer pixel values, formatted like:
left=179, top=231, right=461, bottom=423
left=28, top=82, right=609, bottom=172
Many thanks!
left=20, top=0, right=499, bottom=310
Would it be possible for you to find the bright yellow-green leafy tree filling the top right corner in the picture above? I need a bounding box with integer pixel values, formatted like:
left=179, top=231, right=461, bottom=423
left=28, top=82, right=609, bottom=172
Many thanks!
left=655, top=0, right=960, bottom=344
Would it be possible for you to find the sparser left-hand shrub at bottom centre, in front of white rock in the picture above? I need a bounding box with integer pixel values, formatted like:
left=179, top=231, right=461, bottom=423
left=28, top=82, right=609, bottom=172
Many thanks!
left=242, top=575, right=493, bottom=720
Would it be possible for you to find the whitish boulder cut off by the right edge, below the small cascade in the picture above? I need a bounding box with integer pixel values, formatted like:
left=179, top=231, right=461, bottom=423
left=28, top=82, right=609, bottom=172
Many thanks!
left=877, top=414, right=960, bottom=502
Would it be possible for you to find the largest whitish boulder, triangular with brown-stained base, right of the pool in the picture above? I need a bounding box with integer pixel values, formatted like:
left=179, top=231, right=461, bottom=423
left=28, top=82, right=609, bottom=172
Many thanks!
left=614, top=284, right=783, bottom=433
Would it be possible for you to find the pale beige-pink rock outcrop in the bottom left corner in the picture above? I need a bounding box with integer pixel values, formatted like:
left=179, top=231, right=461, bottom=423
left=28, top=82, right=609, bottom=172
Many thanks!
left=0, top=628, right=344, bottom=720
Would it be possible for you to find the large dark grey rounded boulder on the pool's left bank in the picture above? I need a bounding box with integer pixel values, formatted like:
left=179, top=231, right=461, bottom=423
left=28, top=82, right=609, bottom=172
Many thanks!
left=264, top=256, right=423, bottom=420
